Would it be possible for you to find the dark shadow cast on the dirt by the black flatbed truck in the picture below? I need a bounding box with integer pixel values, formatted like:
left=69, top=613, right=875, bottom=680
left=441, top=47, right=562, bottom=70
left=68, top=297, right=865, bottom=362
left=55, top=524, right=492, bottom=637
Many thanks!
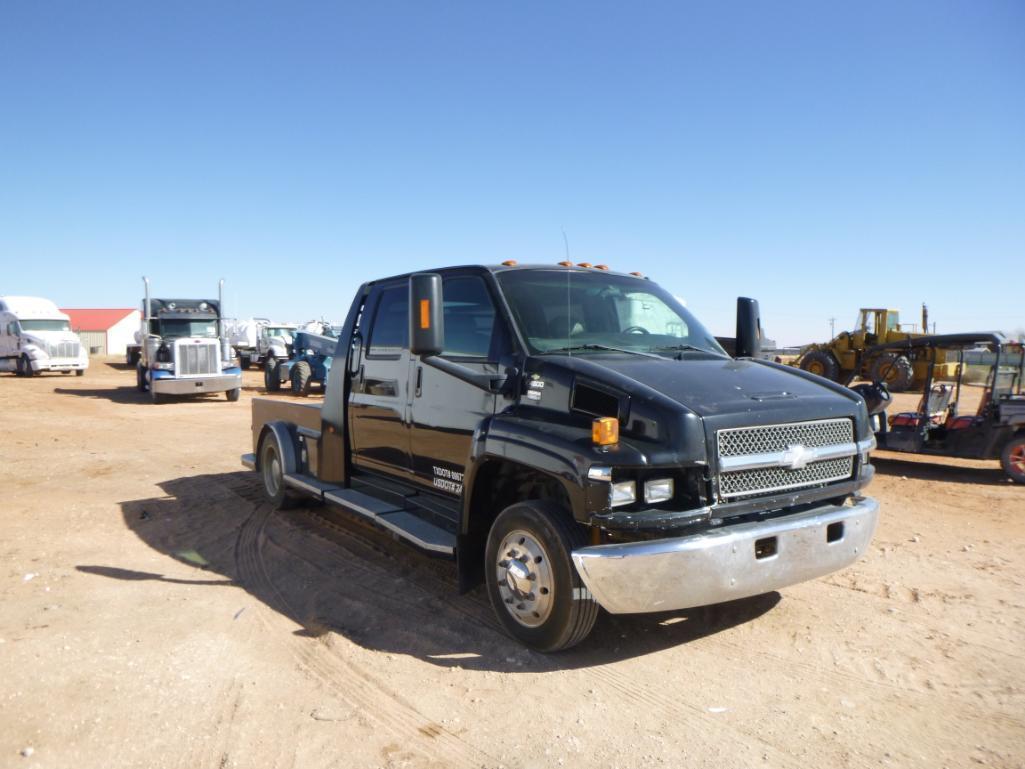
left=99, top=473, right=780, bottom=673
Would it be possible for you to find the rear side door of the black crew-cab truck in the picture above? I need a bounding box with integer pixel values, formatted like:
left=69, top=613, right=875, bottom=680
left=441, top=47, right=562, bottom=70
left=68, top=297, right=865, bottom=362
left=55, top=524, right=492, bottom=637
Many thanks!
left=349, top=281, right=410, bottom=480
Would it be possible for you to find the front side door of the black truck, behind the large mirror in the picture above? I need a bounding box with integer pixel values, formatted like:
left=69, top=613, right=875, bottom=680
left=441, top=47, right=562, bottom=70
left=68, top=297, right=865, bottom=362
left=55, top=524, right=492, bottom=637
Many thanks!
left=410, top=275, right=509, bottom=497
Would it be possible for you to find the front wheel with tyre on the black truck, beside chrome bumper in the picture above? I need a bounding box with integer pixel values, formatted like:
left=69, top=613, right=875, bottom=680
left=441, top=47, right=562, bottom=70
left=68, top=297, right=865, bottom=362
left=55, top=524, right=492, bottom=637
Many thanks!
left=485, top=501, right=598, bottom=652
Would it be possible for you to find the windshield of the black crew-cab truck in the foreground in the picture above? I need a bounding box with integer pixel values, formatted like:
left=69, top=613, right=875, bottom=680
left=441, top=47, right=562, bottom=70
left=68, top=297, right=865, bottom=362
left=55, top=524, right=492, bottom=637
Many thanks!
left=497, top=270, right=726, bottom=355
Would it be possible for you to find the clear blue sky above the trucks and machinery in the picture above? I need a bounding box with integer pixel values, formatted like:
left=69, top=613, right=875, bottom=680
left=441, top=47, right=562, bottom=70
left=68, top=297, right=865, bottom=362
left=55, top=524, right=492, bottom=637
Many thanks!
left=0, top=0, right=1025, bottom=343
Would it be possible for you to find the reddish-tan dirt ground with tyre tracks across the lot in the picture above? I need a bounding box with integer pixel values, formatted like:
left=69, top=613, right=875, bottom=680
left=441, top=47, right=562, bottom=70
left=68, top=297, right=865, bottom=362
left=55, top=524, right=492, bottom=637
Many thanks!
left=0, top=361, right=1025, bottom=769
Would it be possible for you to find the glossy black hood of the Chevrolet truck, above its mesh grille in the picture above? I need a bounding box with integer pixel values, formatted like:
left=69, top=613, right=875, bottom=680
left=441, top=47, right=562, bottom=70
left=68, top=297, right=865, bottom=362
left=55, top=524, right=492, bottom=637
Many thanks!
left=545, top=354, right=867, bottom=434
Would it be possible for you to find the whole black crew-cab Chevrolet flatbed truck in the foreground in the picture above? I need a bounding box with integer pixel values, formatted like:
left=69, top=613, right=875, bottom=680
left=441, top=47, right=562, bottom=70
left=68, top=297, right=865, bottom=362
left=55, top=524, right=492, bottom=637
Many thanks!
left=242, top=262, right=878, bottom=651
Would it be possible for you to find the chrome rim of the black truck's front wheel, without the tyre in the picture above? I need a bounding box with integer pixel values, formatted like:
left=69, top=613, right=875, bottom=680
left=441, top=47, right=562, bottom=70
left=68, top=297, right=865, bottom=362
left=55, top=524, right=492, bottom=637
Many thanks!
left=495, top=529, right=556, bottom=628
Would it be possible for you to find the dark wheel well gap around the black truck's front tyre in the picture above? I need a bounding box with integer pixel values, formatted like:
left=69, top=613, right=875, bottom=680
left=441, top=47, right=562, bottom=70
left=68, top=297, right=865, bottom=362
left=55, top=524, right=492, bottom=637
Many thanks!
left=456, top=459, right=572, bottom=593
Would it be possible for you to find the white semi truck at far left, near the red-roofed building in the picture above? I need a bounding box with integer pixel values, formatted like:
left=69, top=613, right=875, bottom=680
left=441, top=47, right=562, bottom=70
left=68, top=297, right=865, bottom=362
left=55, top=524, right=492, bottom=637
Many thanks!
left=0, top=296, right=89, bottom=376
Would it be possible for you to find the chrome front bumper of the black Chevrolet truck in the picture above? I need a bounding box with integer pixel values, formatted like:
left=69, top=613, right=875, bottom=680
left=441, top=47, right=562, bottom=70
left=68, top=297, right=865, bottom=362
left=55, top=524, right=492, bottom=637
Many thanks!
left=572, top=497, right=879, bottom=614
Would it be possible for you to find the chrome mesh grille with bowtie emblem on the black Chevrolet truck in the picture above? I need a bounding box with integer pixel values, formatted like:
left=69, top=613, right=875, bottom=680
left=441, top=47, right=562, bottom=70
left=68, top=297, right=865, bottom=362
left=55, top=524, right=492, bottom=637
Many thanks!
left=716, top=419, right=858, bottom=501
